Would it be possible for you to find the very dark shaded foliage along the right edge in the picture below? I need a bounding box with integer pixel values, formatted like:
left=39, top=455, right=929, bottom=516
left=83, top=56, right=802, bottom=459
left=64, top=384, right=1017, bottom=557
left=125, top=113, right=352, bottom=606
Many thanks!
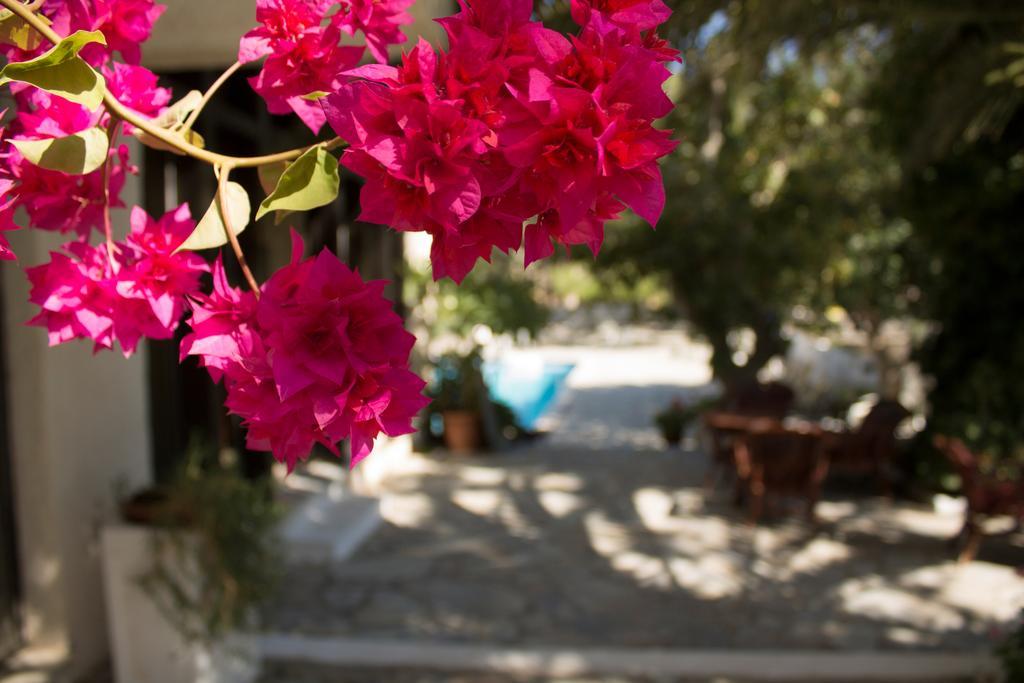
left=873, top=9, right=1024, bottom=460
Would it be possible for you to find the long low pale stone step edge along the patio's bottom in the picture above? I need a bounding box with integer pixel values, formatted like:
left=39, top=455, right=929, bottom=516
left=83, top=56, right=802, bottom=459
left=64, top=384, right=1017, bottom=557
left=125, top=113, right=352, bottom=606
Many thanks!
left=251, top=634, right=998, bottom=683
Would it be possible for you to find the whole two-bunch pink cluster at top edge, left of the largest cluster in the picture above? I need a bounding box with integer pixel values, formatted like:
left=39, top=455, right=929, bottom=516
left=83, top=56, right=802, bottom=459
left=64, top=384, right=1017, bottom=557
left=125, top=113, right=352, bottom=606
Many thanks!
left=239, top=0, right=412, bottom=133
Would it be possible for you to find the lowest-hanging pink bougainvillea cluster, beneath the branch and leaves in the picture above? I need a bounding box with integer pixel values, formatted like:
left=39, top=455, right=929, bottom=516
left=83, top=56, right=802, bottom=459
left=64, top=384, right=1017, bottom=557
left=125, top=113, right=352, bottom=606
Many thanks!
left=181, top=232, right=427, bottom=470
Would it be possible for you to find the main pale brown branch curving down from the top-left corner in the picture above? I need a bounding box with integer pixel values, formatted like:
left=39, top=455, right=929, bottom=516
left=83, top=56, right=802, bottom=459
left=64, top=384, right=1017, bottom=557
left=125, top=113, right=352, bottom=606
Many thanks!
left=0, top=0, right=345, bottom=168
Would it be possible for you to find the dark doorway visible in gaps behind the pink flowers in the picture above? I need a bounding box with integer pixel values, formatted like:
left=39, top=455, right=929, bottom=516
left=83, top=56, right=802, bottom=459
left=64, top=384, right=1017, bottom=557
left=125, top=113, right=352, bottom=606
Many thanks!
left=141, top=65, right=402, bottom=481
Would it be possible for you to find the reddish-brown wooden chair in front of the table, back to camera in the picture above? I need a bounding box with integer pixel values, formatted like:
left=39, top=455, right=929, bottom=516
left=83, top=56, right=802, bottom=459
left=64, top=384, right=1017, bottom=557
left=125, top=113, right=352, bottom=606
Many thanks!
left=733, top=419, right=828, bottom=524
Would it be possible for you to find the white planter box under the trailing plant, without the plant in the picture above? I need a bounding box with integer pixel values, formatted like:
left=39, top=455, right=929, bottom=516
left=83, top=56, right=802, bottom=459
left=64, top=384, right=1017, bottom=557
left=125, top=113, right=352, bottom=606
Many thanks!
left=102, top=524, right=260, bottom=683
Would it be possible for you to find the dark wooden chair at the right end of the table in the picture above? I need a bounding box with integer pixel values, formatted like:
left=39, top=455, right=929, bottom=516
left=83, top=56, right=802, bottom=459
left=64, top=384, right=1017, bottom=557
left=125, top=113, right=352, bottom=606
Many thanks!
left=829, top=400, right=910, bottom=497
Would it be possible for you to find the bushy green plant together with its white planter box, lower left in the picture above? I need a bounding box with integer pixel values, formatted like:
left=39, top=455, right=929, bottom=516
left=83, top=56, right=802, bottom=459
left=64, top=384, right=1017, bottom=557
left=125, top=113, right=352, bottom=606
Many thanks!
left=103, top=448, right=280, bottom=683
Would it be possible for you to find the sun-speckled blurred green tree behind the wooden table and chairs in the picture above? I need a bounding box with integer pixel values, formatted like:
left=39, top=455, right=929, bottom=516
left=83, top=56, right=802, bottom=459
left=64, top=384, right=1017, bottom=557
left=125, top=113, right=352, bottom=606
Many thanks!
left=601, top=15, right=905, bottom=384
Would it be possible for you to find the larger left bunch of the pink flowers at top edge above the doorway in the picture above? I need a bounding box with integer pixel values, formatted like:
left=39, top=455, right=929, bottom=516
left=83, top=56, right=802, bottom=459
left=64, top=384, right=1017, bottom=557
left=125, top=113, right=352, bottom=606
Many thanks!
left=239, top=0, right=362, bottom=133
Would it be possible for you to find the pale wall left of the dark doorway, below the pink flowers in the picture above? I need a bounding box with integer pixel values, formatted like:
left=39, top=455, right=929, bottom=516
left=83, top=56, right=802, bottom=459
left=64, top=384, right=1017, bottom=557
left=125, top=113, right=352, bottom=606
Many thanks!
left=0, top=150, right=152, bottom=672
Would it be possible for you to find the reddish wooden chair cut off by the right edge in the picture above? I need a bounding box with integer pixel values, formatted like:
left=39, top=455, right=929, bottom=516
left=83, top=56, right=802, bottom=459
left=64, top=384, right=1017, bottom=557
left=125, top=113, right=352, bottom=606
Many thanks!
left=933, top=435, right=1024, bottom=562
